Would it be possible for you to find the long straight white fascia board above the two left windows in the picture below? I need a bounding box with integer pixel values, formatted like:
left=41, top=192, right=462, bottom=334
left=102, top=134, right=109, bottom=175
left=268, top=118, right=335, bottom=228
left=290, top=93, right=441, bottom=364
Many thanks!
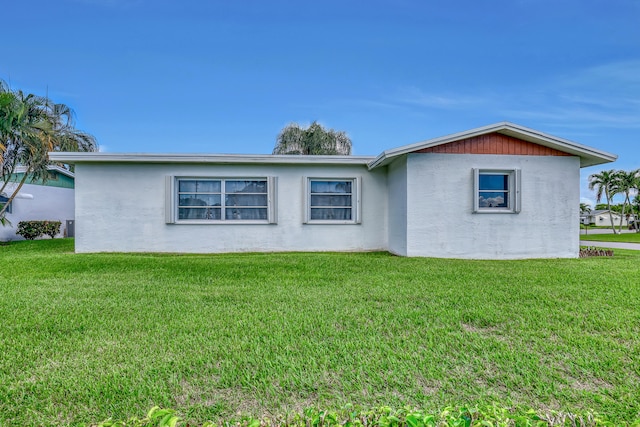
left=49, top=152, right=374, bottom=166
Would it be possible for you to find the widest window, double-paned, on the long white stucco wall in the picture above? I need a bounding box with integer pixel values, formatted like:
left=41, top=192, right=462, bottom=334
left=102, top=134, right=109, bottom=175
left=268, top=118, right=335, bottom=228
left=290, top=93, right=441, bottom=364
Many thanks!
left=167, top=177, right=275, bottom=223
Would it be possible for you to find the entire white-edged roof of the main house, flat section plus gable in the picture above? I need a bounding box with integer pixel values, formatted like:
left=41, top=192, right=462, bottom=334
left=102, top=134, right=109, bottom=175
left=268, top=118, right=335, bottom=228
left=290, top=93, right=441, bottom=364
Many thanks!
left=49, top=122, right=618, bottom=170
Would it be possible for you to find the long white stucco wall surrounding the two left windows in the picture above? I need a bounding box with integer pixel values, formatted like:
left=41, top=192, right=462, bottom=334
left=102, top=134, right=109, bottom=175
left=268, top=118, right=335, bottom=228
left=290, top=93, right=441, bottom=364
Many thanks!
left=75, top=163, right=388, bottom=253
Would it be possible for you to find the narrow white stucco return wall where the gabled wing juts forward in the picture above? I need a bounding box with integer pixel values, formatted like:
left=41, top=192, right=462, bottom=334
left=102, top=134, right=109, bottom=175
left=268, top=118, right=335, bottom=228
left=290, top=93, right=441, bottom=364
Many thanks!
left=388, top=157, right=407, bottom=256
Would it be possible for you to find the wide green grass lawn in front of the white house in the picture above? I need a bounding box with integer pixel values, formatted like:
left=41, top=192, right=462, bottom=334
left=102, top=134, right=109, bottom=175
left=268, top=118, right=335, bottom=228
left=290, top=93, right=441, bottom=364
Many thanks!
left=0, top=240, right=640, bottom=426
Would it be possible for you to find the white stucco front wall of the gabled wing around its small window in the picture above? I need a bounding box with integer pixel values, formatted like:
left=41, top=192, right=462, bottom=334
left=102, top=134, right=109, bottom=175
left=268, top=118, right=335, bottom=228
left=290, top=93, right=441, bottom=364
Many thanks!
left=407, top=154, right=580, bottom=259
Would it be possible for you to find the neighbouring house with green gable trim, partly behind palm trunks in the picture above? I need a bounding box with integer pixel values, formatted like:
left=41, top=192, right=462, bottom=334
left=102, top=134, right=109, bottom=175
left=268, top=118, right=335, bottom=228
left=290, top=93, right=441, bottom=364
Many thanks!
left=0, top=165, right=75, bottom=242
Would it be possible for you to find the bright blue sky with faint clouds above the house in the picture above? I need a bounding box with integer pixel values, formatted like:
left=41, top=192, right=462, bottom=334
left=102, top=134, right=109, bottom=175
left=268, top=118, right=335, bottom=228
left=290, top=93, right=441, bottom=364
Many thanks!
left=0, top=0, right=640, bottom=207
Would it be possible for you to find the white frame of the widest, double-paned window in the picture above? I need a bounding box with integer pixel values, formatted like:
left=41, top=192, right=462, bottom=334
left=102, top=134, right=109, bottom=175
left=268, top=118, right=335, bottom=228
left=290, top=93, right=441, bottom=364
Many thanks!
left=165, top=176, right=278, bottom=224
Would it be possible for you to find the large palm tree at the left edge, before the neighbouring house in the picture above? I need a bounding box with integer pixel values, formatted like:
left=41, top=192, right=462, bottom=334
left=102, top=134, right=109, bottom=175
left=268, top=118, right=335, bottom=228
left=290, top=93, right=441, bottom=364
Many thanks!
left=0, top=81, right=97, bottom=225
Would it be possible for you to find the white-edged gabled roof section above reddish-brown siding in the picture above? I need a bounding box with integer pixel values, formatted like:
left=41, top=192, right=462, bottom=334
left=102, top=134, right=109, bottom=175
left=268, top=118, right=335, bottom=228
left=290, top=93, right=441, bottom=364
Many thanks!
left=369, top=122, right=618, bottom=169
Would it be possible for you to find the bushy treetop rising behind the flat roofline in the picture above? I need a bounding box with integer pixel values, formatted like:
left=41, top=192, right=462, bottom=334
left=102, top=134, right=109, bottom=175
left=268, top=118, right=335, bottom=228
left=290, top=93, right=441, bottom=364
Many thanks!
left=273, top=121, right=351, bottom=156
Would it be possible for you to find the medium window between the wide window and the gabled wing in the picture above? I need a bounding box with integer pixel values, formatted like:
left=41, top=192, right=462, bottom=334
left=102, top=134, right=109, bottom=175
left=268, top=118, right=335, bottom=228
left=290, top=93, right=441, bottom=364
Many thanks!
left=305, top=178, right=360, bottom=224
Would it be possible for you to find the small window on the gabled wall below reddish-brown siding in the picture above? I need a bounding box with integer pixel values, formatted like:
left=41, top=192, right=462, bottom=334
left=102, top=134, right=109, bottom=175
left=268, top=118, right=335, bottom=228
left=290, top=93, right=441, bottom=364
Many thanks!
left=473, top=169, right=520, bottom=213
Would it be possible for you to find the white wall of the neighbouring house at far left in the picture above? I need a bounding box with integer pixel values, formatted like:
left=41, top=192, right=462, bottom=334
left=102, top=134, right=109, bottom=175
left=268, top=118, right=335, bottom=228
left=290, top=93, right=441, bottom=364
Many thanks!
left=0, top=184, right=75, bottom=241
